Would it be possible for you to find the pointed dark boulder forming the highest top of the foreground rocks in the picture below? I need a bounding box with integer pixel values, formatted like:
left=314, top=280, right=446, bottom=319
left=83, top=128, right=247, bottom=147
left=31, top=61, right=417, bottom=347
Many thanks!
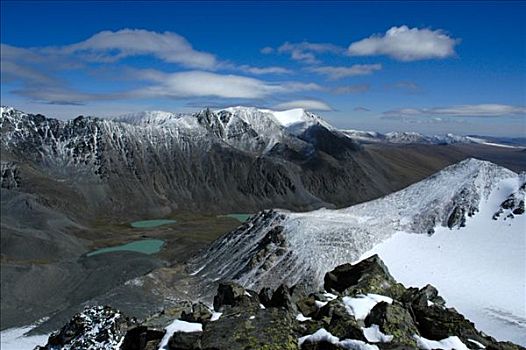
left=324, top=254, right=396, bottom=295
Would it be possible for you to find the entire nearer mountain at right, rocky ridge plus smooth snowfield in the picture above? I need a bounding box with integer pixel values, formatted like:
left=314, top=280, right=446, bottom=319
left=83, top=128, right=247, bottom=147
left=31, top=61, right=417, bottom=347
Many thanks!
left=189, top=159, right=526, bottom=342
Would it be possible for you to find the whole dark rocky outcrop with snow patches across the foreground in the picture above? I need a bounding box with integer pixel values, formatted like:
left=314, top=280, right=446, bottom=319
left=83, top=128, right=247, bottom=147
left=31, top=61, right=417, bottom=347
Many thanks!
left=39, top=256, right=524, bottom=350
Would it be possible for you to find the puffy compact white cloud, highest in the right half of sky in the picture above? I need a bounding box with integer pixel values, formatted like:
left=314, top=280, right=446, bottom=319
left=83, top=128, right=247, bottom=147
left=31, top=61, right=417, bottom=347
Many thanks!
left=348, top=25, right=459, bottom=61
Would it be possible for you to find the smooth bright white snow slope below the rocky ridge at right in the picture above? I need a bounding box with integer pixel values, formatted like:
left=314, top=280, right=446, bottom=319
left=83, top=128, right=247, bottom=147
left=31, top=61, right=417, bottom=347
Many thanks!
left=363, top=174, right=526, bottom=345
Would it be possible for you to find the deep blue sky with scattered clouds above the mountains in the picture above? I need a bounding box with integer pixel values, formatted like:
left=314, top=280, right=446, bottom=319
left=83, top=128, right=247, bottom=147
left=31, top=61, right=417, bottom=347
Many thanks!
left=1, top=1, right=526, bottom=136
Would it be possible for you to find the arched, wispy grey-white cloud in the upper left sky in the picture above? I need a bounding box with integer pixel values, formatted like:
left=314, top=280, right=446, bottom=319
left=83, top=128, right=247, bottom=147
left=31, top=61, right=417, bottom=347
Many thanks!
left=63, top=29, right=218, bottom=69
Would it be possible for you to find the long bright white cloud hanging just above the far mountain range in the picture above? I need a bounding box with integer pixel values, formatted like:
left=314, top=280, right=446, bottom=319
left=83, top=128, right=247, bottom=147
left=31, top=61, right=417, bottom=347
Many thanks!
left=131, top=70, right=321, bottom=99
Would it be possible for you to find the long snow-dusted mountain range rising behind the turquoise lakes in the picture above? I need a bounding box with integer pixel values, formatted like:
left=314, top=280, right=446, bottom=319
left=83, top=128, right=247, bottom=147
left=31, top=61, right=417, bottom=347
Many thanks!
left=0, top=107, right=436, bottom=215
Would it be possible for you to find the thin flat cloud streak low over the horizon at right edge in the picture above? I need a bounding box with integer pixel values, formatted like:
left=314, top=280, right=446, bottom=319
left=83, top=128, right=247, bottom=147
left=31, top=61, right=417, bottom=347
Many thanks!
left=384, top=104, right=526, bottom=118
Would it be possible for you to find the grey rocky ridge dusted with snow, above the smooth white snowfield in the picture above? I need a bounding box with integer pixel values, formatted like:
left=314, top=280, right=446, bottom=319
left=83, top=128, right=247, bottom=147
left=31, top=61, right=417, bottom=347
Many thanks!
left=194, top=159, right=523, bottom=288
